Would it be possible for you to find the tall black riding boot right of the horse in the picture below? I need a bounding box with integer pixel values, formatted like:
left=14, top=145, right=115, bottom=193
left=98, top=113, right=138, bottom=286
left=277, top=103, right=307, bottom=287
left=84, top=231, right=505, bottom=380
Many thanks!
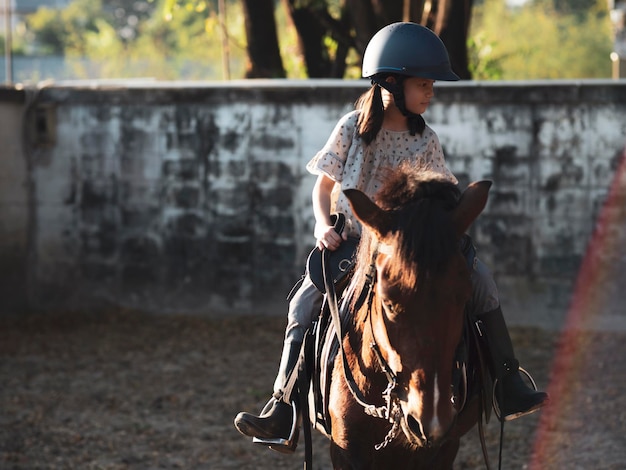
left=477, top=307, right=548, bottom=421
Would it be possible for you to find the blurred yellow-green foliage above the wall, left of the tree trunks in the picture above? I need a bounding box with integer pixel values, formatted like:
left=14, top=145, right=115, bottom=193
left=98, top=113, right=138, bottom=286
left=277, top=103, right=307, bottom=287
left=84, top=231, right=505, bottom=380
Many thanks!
left=17, top=0, right=246, bottom=80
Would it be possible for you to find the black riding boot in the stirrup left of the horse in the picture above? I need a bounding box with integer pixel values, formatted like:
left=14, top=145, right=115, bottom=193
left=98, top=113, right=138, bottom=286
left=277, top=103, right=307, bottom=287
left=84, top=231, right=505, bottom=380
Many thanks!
left=235, top=343, right=301, bottom=453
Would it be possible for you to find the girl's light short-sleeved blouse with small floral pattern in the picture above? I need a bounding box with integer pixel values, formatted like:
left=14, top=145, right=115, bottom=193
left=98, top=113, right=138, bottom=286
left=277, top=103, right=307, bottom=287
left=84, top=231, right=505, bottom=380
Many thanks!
left=306, top=110, right=458, bottom=236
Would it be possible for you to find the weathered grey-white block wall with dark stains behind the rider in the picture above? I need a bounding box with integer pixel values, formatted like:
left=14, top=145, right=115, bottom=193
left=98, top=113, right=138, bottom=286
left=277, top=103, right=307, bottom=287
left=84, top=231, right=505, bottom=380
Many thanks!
left=0, top=81, right=626, bottom=326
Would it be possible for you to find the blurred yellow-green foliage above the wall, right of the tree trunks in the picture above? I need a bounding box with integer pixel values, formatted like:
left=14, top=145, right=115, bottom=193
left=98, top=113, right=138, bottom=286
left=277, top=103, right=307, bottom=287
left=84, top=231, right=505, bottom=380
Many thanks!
left=469, top=0, right=612, bottom=80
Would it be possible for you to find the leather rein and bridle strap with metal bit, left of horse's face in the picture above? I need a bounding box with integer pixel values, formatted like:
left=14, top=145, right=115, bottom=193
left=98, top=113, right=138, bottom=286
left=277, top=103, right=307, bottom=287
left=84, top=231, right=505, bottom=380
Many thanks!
left=322, top=246, right=402, bottom=450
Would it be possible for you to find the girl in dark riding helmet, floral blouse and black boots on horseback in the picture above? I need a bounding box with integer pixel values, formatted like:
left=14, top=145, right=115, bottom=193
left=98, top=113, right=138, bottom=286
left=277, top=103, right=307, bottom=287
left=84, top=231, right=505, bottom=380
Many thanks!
left=235, top=22, right=548, bottom=452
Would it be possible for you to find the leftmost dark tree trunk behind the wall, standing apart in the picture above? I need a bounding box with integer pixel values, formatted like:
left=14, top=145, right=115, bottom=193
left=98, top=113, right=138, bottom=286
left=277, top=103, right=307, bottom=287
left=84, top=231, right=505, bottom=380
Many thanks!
left=243, top=0, right=286, bottom=78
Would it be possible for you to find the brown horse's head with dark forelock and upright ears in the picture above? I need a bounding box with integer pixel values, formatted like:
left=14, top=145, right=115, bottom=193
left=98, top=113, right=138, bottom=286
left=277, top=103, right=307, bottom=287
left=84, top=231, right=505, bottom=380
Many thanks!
left=345, top=168, right=491, bottom=446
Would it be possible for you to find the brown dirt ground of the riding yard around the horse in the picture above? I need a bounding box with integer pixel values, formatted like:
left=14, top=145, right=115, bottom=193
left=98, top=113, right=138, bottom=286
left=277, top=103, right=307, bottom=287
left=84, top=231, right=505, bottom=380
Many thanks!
left=0, top=311, right=626, bottom=470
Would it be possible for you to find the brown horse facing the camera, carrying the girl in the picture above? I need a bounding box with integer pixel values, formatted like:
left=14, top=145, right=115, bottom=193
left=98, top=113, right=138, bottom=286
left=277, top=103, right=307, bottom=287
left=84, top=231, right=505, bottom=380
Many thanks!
left=328, top=167, right=491, bottom=469
